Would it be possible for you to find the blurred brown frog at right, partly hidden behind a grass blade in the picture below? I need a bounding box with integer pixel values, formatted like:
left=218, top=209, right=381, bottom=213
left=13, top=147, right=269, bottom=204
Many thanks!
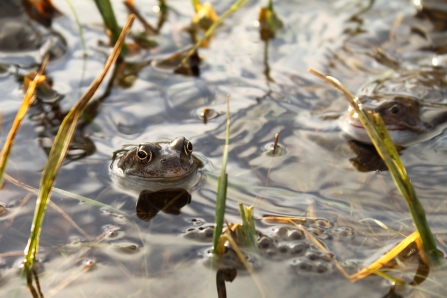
left=340, top=96, right=447, bottom=145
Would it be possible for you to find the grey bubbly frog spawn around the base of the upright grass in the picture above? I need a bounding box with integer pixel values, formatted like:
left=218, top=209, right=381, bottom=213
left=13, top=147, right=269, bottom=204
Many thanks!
left=184, top=218, right=354, bottom=275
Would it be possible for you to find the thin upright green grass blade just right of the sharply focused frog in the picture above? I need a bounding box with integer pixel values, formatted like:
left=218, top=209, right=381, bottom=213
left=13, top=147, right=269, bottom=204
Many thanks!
left=213, top=95, right=231, bottom=254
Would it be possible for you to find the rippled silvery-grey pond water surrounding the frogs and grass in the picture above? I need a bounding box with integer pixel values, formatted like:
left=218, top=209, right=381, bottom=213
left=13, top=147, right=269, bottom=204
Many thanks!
left=0, top=1, right=447, bottom=297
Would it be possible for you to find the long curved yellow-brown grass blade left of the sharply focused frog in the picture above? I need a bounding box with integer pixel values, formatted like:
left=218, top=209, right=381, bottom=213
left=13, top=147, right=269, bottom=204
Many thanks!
left=23, top=15, right=135, bottom=274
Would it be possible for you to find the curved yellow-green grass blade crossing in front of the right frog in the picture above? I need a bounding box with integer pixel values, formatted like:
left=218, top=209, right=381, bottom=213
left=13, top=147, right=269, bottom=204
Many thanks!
left=309, top=68, right=441, bottom=265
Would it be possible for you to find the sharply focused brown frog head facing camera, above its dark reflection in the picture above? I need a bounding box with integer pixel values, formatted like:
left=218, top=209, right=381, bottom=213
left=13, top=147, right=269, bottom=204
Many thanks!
left=110, top=137, right=203, bottom=192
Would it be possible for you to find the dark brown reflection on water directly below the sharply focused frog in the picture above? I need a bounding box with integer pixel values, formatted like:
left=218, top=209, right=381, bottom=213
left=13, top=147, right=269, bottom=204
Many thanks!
left=136, top=188, right=191, bottom=221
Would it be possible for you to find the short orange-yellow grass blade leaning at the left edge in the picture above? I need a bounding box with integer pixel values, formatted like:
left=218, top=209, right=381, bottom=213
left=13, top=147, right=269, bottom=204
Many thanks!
left=0, top=55, right=49, bottom=187
